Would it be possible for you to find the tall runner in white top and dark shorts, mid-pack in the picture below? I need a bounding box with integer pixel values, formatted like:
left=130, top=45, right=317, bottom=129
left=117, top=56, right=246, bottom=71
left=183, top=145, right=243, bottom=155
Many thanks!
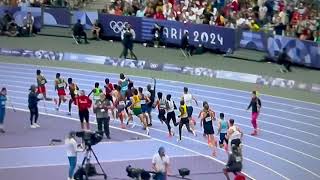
left=181, top=87, right=198, bottom=136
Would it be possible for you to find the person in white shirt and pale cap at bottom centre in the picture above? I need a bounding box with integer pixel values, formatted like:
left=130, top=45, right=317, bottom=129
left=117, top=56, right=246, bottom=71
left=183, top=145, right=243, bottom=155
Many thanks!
left=152, top=147, right=170, bottom=180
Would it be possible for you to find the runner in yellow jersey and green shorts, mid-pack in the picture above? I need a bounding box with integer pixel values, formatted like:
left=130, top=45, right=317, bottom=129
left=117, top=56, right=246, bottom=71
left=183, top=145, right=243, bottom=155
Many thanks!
left=131, top=89, right=149, bottom=135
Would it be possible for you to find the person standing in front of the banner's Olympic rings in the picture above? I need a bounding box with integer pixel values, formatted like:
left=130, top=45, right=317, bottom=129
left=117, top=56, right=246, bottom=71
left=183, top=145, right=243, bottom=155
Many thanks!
left=120, top=24, right=138, bottom=60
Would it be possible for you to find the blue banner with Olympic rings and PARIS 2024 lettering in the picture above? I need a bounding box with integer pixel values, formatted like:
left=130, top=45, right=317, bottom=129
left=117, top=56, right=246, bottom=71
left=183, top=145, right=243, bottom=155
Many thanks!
left=99, top=14, right=236, bottom=52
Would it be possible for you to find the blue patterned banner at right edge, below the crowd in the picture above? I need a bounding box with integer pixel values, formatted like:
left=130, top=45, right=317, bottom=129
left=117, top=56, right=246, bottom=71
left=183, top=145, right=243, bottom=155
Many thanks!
left=268, top=35, right=320, bottom=68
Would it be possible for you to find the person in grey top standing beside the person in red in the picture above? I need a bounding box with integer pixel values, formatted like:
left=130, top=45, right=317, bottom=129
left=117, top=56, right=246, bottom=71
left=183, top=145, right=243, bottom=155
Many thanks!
left=94, top=93, right=112, bottom=139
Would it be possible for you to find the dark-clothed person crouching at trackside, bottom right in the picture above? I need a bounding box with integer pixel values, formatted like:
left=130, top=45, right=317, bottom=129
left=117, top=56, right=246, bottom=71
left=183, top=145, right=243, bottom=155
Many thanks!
left=223, top=146, right=242, bottom=180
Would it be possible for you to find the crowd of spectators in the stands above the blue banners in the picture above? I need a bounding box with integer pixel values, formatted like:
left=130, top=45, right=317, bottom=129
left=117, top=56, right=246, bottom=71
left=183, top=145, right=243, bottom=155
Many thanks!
left=104, top=0, right=320, bottom=43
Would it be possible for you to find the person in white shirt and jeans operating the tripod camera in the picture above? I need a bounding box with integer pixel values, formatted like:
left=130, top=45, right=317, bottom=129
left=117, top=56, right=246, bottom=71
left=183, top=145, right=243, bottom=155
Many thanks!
left=65, top=131, right=84, bottom=180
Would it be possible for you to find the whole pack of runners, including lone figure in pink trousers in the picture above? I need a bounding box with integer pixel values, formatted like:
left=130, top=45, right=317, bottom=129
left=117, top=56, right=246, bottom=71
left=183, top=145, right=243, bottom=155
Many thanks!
left=37, top=70, right=261, bottom=156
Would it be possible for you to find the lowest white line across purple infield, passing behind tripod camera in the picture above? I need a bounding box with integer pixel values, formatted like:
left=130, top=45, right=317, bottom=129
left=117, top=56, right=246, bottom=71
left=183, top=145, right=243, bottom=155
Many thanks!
left=0, top=154, right=202, bottom=170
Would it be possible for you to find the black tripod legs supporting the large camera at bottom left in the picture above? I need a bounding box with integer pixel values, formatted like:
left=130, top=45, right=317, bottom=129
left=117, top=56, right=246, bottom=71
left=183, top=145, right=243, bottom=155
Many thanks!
left=75, top=146, right=107, bottom=180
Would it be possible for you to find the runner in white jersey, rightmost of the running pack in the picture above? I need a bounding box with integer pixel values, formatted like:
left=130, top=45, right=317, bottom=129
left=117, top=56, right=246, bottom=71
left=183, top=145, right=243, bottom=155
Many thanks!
left=226, top=119, right=243, bottom=153
